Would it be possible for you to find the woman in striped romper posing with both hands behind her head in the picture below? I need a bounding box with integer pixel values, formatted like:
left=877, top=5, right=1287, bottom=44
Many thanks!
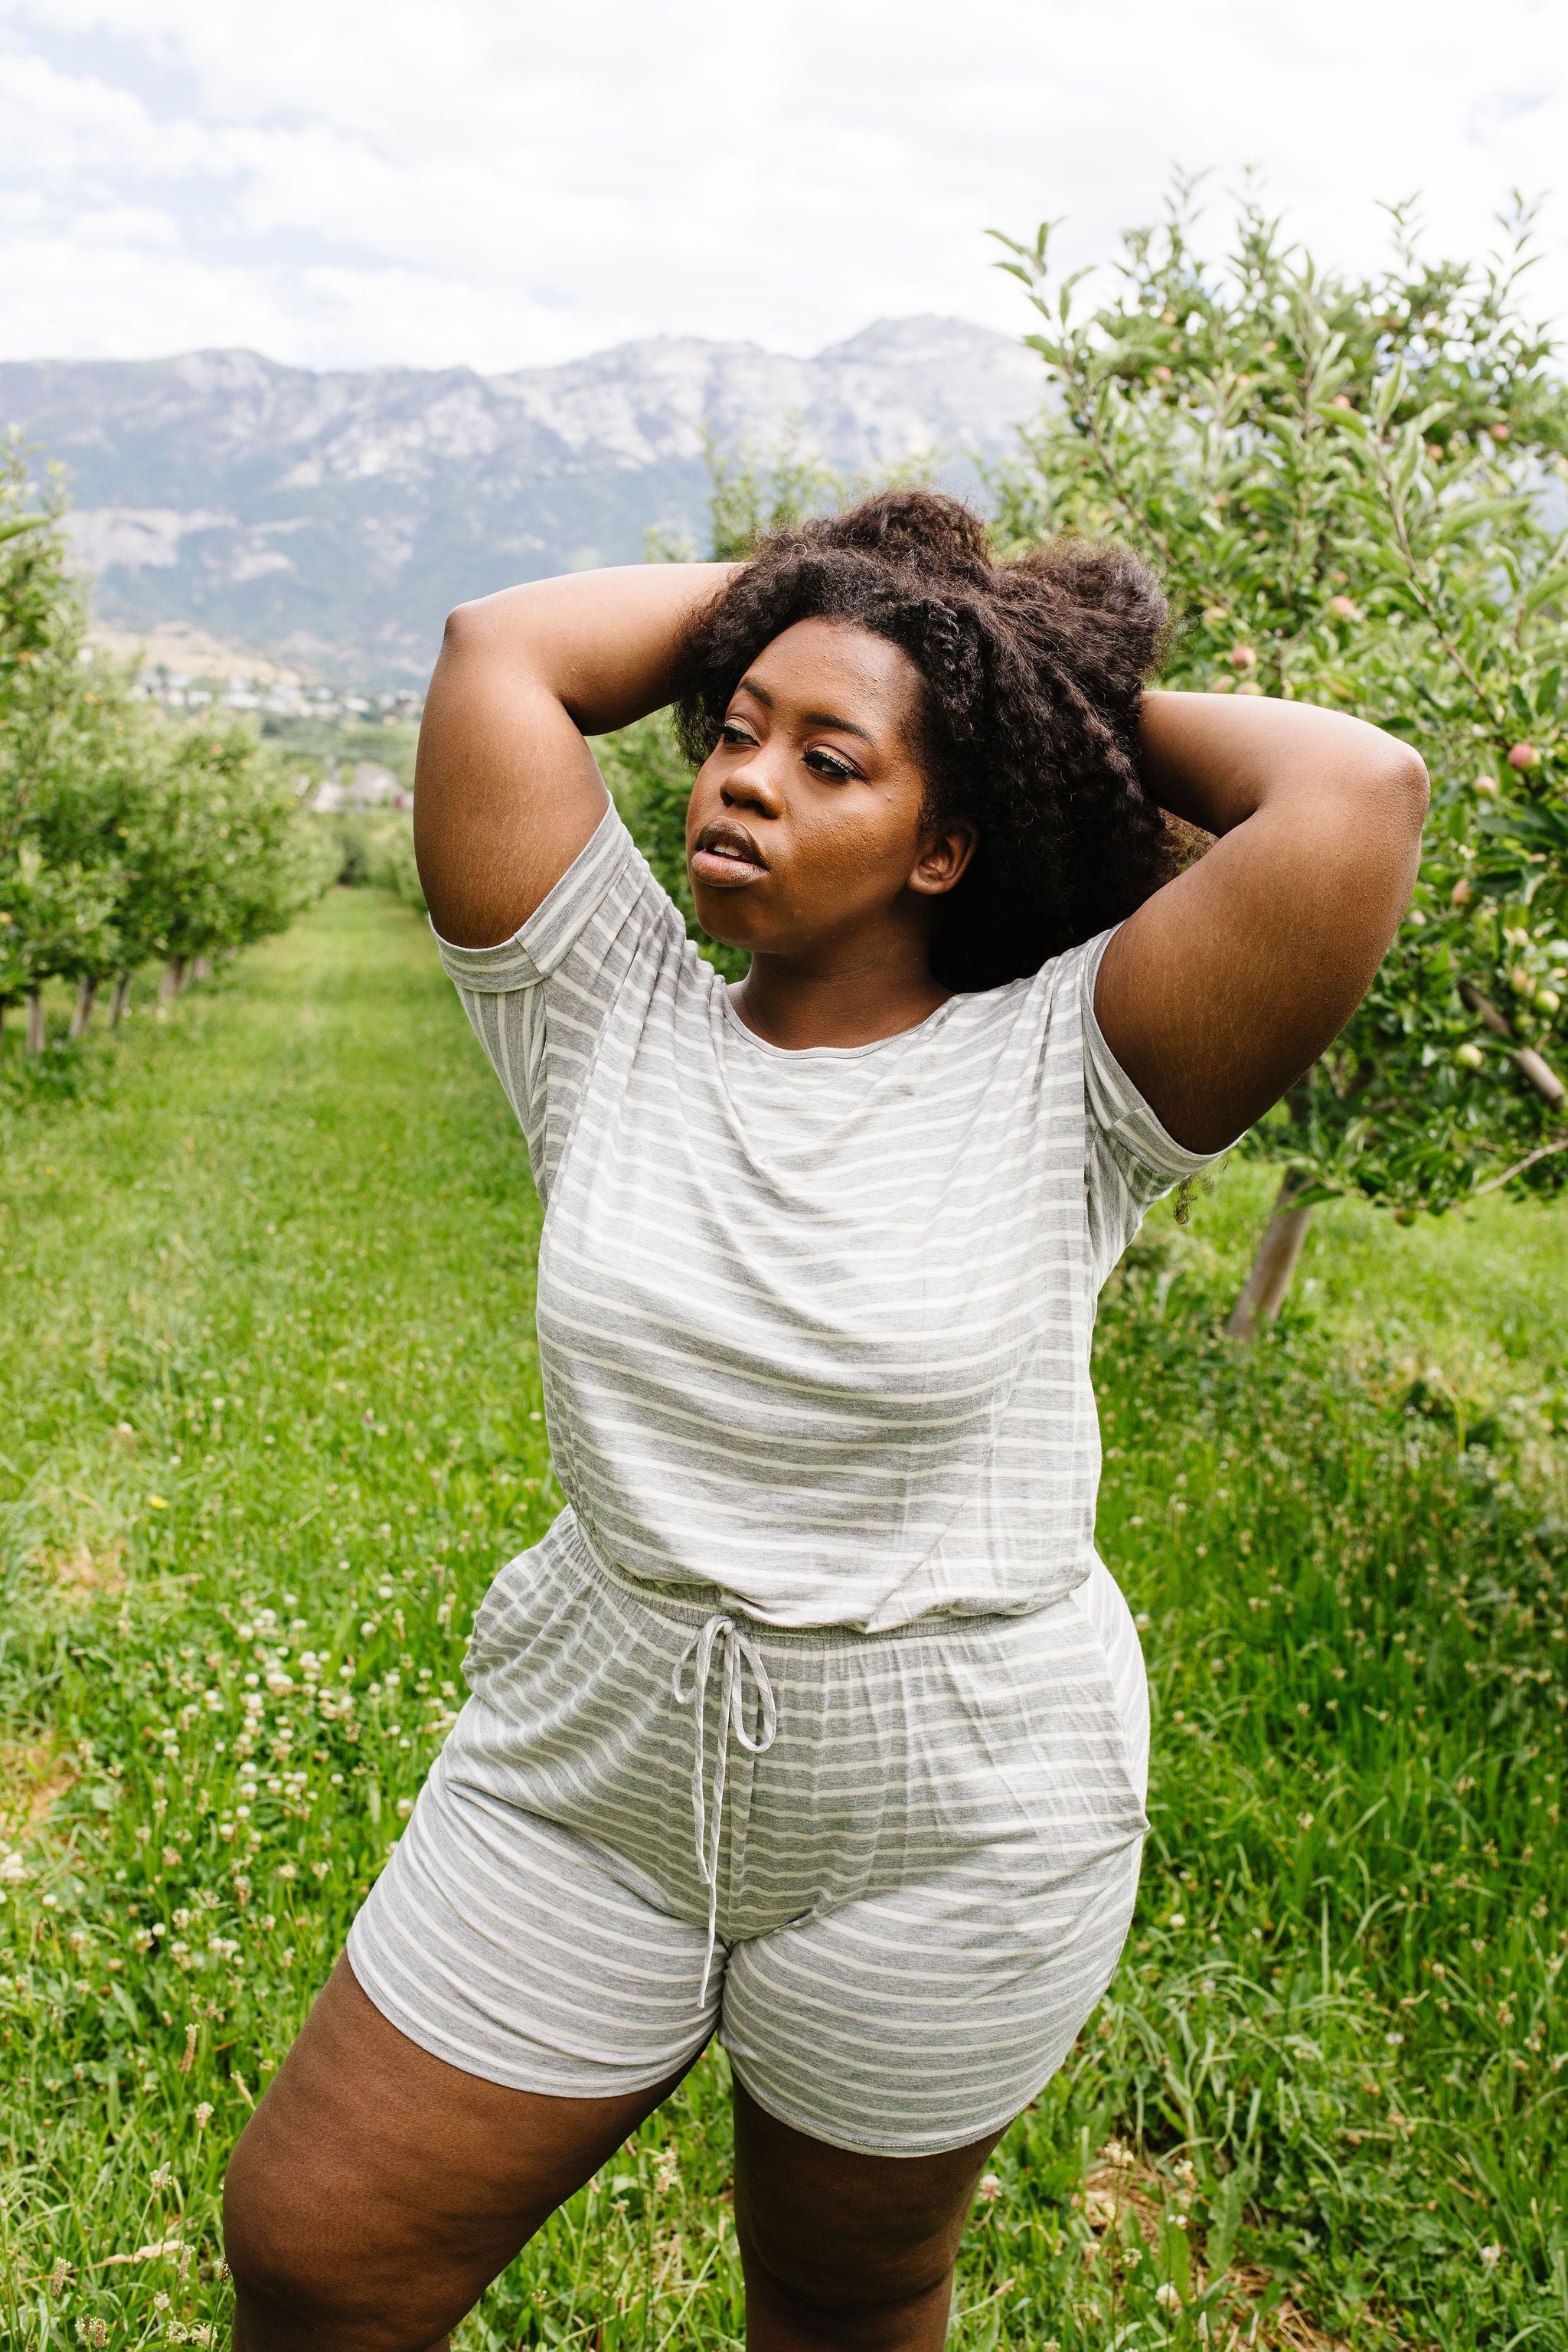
left=228, top=492, right=1427, bottom=2352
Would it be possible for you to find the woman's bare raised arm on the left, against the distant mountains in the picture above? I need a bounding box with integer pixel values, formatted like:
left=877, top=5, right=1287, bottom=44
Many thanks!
left=413, top=564, right=738, bottom=948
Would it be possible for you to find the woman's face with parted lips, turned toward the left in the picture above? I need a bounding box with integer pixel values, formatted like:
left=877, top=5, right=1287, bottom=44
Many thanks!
left=687, top=621, right=973, bottom=955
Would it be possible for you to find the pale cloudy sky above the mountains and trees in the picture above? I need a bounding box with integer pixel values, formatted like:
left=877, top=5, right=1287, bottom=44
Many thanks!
left=0, top=0, right=1568, bottom=371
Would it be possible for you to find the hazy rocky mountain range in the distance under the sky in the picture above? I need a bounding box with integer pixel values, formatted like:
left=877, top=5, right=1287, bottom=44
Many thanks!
left=0, top=318, right=1041, bottom=680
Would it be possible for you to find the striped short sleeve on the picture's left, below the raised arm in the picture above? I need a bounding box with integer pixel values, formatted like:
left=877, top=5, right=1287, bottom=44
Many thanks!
left=433, top=807, right=687, bottom=1197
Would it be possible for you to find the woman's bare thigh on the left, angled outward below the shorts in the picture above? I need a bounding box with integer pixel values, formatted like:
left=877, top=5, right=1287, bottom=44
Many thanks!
left=224, top=1959, right=684, bottom=2352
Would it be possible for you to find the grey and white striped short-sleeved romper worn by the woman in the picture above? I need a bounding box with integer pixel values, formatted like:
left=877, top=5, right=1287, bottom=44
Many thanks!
left=348, top=809, right=1204, bottom=2157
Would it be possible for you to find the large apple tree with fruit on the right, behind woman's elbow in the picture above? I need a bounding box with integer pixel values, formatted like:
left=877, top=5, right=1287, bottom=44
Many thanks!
left=995, top=186, right=1568, bottom=1336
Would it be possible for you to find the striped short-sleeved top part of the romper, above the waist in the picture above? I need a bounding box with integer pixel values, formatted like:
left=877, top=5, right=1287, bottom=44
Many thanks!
left=442, top=809, right=1204, bottom=1632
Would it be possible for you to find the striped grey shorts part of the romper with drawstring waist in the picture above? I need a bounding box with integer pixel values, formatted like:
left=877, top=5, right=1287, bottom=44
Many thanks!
left=348, top=1512, right=1147, bottom=2157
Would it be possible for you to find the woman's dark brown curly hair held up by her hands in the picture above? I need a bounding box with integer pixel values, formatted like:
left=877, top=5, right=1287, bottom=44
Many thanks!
left=675, top=489, right=1173, bottom=990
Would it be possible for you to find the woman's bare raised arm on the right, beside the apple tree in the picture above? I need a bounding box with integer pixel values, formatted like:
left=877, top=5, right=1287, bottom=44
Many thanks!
left=1096, top=694, right=1427, bottom=1152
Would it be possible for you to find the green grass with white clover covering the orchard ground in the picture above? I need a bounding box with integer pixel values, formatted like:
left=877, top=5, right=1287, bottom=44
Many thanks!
left=0, top=891, right=1568, bottom=2352
